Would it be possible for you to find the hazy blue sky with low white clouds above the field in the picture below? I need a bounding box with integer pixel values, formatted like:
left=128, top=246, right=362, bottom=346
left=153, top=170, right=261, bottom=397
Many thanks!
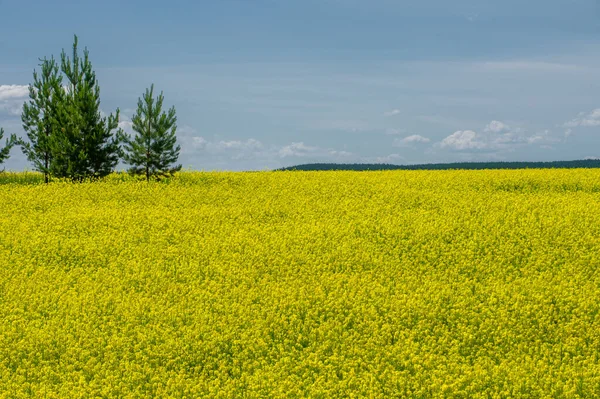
left=0, top=0, right=600, bottom=170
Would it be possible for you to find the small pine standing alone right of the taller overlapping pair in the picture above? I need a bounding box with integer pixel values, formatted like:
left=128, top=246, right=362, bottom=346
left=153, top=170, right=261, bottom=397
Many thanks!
left=121, top=85, right=181, bottom=181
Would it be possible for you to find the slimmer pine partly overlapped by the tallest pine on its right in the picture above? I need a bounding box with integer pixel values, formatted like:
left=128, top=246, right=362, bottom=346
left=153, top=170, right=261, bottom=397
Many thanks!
left=18, top=58, right=64, bottom=183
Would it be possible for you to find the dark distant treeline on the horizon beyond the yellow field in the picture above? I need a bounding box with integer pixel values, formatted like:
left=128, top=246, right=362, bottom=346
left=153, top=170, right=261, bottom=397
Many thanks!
left=277, top=159, right=600, bottom=171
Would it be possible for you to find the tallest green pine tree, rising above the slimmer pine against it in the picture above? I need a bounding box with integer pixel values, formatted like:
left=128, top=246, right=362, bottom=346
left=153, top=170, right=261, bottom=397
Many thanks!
left=51, top=36, right=120, bottom=181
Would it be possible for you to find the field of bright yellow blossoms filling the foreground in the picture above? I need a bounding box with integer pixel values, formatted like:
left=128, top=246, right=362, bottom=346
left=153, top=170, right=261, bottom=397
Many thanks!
left=0, top=169, right=600, bottom=398
